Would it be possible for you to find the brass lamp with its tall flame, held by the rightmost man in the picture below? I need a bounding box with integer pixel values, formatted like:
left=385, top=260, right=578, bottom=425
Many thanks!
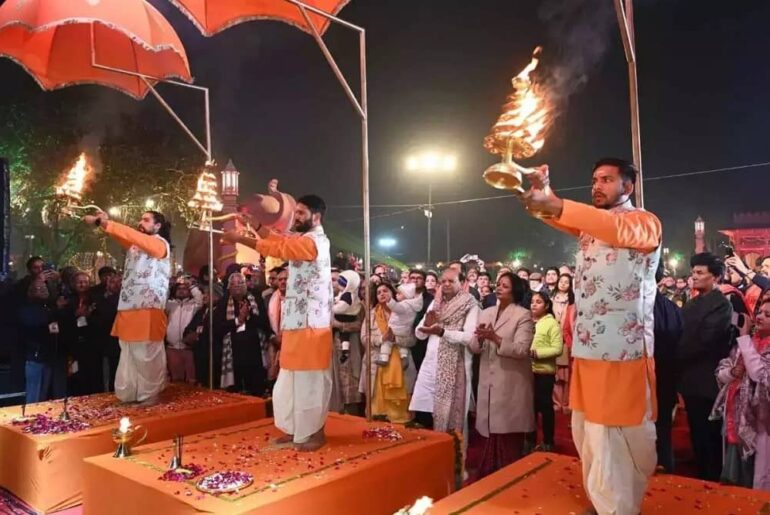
left=484, top=47, right=551, bottom=206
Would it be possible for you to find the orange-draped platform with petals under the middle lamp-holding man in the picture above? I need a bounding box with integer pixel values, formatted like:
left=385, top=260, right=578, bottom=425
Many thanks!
left=83, top=414, right=454, bottom=515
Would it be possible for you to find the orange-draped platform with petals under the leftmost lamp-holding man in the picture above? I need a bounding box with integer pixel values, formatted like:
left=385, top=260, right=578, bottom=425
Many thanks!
left=0, top=385, right=265, bottom=513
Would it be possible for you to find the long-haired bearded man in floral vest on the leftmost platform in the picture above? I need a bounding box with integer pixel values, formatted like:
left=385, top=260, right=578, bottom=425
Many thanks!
left=83, top=211, right=171, bottom=405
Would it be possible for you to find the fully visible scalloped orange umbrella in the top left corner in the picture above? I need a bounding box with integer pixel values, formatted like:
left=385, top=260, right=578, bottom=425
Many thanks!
left=0, top=0, right=192, bottom=99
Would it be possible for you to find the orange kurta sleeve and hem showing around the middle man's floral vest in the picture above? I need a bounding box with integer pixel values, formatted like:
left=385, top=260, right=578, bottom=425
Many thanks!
left=256, top=232, right=332, bottom=370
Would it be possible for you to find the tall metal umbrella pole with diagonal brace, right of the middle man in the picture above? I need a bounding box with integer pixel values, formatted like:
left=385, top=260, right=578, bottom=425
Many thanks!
left=286, top=0, right=372, bottom=421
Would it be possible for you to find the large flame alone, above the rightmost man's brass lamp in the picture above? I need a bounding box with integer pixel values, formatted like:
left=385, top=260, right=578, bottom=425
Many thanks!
left=484, top=47, right=551, bottom=158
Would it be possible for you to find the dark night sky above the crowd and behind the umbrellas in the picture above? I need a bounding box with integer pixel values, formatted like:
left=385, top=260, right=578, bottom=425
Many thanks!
left=0, top=0, right=770, bottom=270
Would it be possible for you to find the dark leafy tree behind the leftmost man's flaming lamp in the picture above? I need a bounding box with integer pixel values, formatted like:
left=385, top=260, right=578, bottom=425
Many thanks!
left=0, top=97, right=200, bottom=265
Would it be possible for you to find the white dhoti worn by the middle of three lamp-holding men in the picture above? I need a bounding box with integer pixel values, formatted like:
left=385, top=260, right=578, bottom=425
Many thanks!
left=273, top=368, right=332, bottom=443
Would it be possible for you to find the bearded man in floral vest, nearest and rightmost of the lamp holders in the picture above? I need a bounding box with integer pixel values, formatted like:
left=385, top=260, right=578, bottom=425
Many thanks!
left=522, top=158, right=662, bottom=514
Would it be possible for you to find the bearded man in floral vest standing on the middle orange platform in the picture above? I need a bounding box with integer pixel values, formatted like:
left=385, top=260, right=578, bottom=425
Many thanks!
left=223, top=195, right=333, bottom=451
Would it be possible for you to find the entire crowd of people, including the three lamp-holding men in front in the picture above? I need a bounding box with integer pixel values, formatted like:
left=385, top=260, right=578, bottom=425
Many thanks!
left=6, top=159, right=770, bottom=513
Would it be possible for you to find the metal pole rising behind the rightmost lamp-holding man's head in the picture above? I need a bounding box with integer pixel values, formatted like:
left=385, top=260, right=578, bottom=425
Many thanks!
left=613, top=0, right=644, bottom=208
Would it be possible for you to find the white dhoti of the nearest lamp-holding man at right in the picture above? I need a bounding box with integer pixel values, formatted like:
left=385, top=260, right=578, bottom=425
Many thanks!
left=572, top=390, right=658, bottom=515
